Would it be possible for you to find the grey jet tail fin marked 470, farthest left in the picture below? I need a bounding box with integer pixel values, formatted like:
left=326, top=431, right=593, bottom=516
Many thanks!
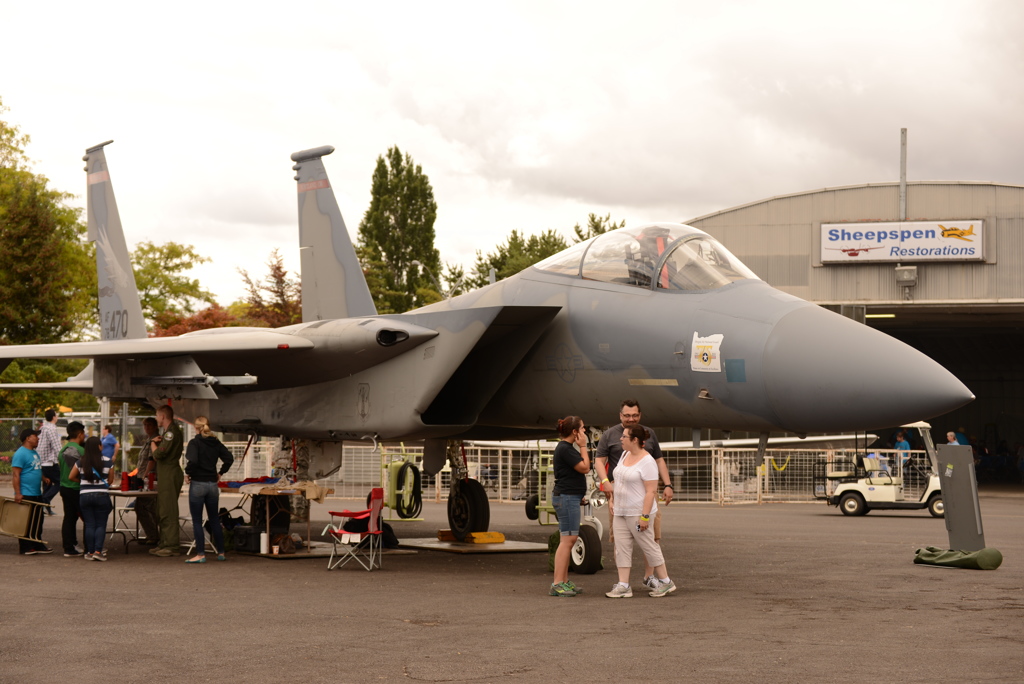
left=82, top=140, right=146, bottom=340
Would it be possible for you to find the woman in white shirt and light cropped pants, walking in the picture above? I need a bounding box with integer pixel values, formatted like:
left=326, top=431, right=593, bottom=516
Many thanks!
left=605, top=425, right=676, bottom=598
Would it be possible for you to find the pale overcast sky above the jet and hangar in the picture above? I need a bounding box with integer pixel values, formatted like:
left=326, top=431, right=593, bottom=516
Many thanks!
left=0, top=0, right=1024, bottom=304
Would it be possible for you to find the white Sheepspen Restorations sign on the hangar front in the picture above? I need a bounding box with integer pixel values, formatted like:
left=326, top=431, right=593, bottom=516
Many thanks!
left=821, top=219, right=985, bottom=263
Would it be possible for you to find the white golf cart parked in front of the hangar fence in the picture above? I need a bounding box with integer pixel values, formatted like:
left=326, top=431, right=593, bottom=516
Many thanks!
left=814, top=422, right=945, bottom=518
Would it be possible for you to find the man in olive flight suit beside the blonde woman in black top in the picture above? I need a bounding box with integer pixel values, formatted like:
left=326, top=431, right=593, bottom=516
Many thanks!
left=150, top=407, right=185, bottom=556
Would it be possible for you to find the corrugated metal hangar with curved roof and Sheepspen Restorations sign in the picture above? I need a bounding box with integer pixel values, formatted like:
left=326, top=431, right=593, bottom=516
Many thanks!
left=686, top=181, right=1024, bottom=451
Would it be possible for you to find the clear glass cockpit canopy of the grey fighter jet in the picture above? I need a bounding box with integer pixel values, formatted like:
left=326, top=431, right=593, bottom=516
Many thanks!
left=536, top=223, right=759, bottom=292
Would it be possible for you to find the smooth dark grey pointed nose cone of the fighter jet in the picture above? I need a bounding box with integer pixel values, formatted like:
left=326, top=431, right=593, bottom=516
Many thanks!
left=764, top=306, right=974, bottom=432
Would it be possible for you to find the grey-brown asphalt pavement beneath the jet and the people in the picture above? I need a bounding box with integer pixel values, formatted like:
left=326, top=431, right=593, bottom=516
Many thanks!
left=0, top=488, right=1024, bottom=684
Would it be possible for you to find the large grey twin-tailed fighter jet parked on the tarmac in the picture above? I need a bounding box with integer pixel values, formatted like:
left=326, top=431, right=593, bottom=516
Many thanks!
left=0, top=145, right=974, bottom=537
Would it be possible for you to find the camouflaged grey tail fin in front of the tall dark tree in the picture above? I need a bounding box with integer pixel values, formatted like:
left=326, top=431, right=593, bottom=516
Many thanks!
left=292, top=145, right=377, bottom=323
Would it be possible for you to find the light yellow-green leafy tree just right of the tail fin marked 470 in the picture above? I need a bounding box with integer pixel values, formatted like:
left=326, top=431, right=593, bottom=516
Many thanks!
left=132, top=242, right=217, bottom=322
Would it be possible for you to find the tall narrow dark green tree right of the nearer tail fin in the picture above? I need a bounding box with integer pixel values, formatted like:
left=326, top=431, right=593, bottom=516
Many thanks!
left=359, top=146, right=440, bottom=313
